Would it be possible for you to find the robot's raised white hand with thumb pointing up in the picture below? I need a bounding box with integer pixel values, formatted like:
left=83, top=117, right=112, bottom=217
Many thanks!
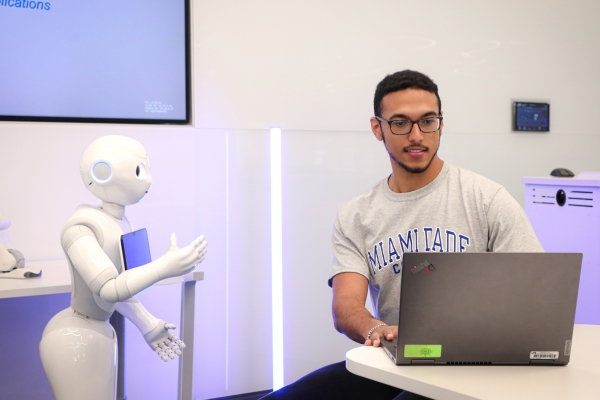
left=156, top=233, right=207, bottom=279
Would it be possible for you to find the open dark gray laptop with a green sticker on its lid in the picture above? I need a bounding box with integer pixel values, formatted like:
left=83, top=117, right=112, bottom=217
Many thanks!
left=382, top=253, right=584, bottom=365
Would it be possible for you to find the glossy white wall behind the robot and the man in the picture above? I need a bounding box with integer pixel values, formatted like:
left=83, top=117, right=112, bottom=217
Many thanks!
left=0, top=0, right=600, bottom=399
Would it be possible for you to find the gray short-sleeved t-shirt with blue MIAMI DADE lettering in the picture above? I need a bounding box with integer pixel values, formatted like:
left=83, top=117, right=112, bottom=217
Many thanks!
left=329, top=163, right=544, bottom=325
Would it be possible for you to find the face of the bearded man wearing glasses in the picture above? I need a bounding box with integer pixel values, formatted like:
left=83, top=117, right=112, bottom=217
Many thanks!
left=371, top=89, right=444, bottom=174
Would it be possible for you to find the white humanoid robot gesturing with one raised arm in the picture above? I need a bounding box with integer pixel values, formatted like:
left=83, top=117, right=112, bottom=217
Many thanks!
left=40, top=135, right=206, bottom=400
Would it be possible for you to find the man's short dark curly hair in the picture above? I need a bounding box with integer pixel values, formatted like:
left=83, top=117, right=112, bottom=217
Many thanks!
left=373, top=69, right=442, bottom=117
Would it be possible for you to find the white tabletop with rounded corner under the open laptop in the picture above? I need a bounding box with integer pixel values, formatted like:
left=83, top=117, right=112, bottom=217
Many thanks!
left=346, top=325, right=600, bottom=400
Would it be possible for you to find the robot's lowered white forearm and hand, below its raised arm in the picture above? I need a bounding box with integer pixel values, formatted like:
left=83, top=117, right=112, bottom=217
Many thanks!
left=117, top=298, right=185, bottom=362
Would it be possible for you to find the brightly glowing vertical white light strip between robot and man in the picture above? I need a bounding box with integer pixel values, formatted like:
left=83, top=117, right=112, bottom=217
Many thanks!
left=271, top=128, right=283, bottom=390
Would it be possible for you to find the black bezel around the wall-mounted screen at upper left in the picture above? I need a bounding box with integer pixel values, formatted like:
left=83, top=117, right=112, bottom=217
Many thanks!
left=0, top=0, right=192, bottom=125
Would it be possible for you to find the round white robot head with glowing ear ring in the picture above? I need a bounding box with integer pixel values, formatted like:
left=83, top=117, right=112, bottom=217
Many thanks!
left=79, top=135, right=152, bottom=206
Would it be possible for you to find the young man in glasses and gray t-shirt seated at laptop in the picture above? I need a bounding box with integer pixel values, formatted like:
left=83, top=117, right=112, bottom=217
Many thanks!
left=262, top=70, right=543, bottom=400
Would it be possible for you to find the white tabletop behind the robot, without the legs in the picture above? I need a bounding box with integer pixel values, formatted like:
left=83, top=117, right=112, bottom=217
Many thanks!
left=0, top=260, right=204, bottom=299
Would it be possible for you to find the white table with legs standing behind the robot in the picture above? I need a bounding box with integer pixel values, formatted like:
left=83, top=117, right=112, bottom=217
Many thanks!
left=0, top=260, right=204, bottom=400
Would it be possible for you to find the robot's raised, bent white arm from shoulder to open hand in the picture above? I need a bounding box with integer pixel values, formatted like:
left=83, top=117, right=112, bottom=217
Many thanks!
left=62, top=225, right=207, bottom=303
